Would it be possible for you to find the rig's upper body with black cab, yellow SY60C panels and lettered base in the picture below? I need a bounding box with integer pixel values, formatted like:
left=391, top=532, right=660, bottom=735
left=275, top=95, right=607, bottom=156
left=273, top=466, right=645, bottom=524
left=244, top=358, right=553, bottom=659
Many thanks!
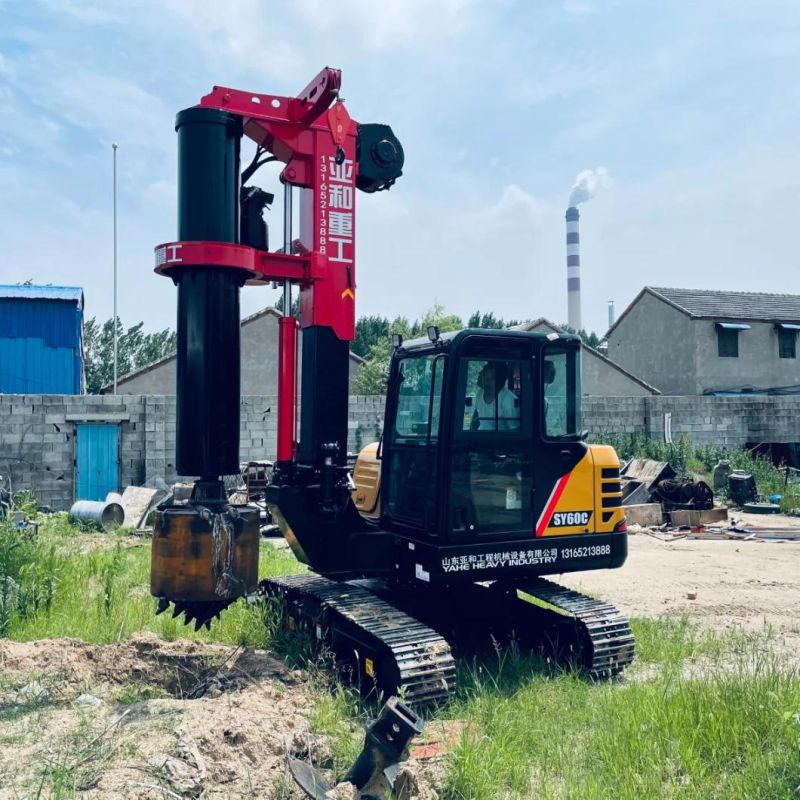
left=353, top=329, right=626, bottom=581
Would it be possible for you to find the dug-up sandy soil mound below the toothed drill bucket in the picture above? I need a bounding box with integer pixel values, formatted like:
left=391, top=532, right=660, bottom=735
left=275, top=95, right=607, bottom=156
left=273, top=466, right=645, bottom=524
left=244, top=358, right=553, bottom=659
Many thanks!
left=0, top=635, right=312, bottom=800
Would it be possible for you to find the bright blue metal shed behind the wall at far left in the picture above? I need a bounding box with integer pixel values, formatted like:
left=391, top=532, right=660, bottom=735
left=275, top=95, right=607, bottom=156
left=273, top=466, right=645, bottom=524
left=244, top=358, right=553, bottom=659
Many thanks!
left=0, top=285, right=83, bottom=394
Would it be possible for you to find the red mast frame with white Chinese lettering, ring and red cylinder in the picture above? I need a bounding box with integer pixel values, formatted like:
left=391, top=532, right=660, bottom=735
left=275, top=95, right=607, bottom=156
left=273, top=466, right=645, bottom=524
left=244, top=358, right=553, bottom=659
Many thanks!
left=155, top=67, right=358, bottom=461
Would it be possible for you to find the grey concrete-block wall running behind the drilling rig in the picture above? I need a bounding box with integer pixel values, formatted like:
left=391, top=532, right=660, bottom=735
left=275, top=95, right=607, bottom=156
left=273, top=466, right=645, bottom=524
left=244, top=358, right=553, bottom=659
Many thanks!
left=0, top=395, right=800, bottom=509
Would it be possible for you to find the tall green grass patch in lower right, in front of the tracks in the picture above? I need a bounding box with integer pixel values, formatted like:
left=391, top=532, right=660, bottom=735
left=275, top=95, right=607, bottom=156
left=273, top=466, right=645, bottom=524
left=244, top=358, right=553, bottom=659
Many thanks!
left=445, top=632, right=800, bottom=800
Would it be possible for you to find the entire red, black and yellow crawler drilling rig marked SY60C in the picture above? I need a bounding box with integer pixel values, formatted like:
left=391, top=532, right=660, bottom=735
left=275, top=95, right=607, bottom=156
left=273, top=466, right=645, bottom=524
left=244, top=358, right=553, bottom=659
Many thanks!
left=151, top=68, right=634, bottom=705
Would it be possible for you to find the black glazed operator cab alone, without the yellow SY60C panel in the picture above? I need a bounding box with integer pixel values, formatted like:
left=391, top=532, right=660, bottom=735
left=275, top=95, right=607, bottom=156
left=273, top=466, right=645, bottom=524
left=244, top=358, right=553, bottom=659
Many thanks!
left=381, top=324, right=587, bottom=544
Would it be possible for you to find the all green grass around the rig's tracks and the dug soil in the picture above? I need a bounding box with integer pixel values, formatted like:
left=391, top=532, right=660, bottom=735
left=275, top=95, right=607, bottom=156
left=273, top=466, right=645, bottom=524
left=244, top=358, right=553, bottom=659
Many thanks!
left=0, top=518, right=800, bottom=800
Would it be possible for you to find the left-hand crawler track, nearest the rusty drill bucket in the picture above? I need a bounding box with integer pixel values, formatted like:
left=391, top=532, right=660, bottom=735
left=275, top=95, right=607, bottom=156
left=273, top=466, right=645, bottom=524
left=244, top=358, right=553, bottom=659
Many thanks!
left=259, top=574, right=456, bottom=707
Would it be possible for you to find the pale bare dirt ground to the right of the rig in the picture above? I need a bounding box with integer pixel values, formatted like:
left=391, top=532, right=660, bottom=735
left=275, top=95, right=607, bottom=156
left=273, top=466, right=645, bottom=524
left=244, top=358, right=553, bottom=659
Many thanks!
left=559, top=515, right=800, bottom=651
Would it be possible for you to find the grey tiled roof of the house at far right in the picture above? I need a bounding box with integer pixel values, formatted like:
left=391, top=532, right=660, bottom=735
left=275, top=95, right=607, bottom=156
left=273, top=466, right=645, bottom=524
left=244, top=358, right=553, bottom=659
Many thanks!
left=647, top=286, right=800, bottom=322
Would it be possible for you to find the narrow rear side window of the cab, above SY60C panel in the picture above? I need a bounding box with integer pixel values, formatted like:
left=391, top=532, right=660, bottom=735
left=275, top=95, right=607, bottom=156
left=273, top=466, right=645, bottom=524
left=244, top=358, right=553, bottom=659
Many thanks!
left=542, top=344, right=582, bottom=439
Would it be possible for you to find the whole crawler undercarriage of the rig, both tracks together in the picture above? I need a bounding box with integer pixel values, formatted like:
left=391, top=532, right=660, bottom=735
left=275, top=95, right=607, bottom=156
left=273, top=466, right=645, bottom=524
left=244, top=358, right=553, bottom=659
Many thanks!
left=259, top=573, right=635, bottom=707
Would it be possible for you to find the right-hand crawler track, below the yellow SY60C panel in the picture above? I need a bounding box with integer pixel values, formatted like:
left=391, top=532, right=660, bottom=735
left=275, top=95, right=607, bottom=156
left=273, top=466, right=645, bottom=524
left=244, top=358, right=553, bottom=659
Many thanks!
left=514, top=578, right=635, bottom=679
